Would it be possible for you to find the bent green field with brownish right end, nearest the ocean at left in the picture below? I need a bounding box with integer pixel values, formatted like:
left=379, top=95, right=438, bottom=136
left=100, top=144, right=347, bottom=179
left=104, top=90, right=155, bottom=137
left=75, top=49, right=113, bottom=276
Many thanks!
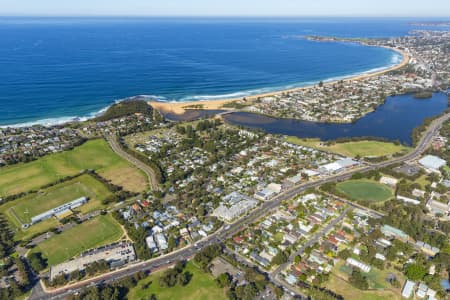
left=0, top=139, right=148, bottom=197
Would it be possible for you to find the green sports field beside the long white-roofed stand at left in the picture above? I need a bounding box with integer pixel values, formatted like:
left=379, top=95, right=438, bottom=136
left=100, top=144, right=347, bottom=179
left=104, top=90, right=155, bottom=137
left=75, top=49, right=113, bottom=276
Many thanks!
left=0, top=174, right=111, bottom=227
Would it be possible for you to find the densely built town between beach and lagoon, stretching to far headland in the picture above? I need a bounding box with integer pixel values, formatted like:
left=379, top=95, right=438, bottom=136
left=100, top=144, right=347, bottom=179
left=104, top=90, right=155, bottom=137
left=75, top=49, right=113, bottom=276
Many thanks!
left=206, top=30, right=450, bottom=123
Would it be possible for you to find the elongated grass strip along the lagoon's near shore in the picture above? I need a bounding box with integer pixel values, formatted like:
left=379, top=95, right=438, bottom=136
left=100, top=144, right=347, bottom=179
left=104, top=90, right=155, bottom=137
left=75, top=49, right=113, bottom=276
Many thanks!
left=286, top=136, right=411, bottom=157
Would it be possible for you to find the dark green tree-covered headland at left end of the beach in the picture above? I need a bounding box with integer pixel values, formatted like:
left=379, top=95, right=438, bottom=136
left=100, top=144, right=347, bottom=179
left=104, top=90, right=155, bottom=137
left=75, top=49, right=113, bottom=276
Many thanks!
left=94, top=100, right=153, bottom=122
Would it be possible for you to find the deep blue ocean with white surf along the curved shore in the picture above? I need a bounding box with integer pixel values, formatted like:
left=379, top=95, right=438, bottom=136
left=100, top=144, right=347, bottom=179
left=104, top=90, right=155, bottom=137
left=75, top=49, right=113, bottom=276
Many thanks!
left=0, top=18, right=442, bottom=125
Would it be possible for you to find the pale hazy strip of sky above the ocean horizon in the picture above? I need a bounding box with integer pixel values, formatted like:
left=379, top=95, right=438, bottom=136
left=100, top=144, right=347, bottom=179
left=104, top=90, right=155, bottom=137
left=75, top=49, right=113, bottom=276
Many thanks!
left=0, top=0, right=450, bottom=17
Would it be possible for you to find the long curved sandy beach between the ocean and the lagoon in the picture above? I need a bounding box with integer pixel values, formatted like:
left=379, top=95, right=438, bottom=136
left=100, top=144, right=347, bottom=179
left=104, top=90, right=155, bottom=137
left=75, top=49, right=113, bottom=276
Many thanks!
left=148, top=47, right=410, bottom=115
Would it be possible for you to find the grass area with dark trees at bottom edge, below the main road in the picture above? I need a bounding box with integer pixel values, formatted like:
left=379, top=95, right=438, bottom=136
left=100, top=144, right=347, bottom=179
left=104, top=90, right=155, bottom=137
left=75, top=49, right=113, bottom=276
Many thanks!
left=127, top=262, right=228, bottom=300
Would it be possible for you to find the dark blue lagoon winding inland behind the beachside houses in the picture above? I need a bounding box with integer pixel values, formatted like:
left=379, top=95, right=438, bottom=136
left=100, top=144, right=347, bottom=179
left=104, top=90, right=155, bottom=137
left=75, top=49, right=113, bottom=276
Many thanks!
left=223, top=92, right=449, bottom=145
